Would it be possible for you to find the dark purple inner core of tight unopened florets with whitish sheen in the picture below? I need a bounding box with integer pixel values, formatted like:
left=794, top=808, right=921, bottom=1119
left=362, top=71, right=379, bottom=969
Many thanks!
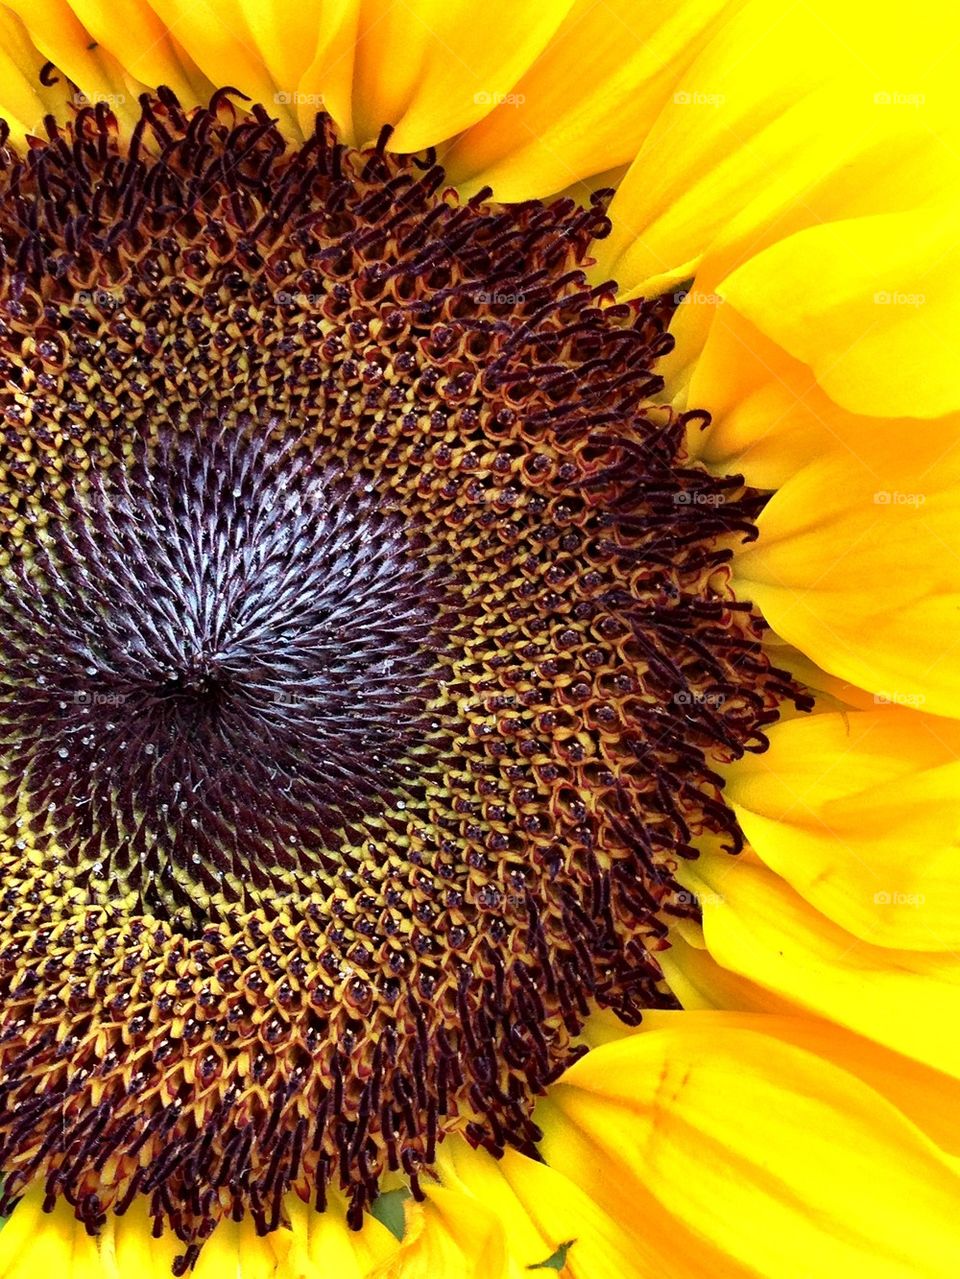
left=0, top=421, right=444, bottom=932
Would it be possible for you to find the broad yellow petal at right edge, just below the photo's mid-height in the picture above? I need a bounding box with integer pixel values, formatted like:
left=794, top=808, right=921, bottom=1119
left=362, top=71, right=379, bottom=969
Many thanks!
left=726, top=706, right=960, bottom=950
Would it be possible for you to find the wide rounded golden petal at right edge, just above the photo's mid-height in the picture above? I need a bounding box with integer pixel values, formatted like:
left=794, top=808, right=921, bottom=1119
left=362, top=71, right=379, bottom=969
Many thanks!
left=734, top=422, right=960, bottom=715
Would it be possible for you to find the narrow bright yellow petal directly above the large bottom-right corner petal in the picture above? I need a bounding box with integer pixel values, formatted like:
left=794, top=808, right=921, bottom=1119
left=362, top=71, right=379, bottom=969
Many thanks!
left=683, top=853, right=960, bottom=1076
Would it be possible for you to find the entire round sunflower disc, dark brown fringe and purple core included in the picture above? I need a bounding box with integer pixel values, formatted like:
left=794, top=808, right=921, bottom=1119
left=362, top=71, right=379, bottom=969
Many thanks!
left=0, top=91, right=798, bottom=1267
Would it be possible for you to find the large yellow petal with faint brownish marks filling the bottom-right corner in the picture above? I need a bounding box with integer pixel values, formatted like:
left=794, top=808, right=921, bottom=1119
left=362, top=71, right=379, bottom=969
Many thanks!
left=541, top=1014, right=960, bottom=1279
